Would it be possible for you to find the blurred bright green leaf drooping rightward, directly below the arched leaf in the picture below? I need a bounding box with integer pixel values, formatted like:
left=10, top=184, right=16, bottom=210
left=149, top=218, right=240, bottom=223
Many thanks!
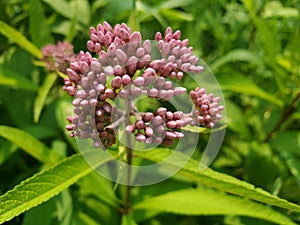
left=219, top=74, right=283, bottom=107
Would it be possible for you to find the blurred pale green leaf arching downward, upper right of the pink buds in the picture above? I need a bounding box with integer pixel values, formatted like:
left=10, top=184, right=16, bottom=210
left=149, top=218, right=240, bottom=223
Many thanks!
left=210, top=49, right=263, bottom=71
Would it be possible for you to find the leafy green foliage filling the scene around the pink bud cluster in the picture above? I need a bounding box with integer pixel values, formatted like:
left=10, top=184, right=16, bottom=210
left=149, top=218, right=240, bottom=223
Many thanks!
left=0, top=0, right=300, bottom=225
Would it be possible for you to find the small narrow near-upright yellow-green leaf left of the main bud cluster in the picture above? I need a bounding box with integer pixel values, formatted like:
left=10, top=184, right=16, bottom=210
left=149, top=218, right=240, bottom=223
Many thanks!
left=33, top=73, right=57, bottom=123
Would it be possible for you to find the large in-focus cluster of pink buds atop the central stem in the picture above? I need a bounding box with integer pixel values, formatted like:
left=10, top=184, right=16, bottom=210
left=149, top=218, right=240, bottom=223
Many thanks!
left=49, top=22, right=223, bottom=149
